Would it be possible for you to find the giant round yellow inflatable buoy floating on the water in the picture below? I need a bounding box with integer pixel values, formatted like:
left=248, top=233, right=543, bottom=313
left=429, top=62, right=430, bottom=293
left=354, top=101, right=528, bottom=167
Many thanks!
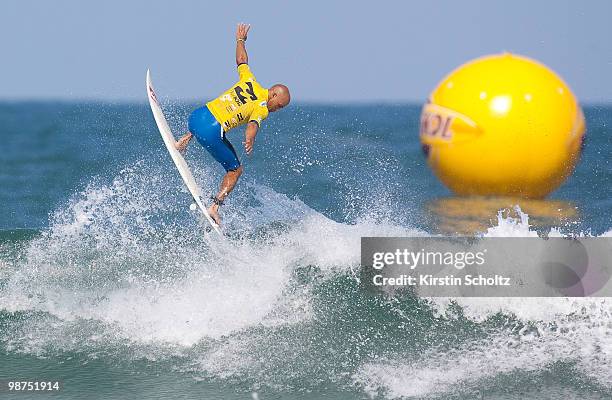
left=420, top=53, right=585, bottom=198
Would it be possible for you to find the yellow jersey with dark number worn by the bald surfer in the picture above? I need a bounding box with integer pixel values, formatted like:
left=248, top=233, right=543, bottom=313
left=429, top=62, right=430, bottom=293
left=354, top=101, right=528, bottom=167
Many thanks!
left=206, top=64, right=268, bottom=132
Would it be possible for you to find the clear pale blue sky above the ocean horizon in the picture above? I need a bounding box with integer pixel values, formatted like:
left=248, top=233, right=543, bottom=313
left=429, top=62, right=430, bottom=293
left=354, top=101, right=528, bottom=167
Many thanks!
left=0, top=0, right=612, bottom=103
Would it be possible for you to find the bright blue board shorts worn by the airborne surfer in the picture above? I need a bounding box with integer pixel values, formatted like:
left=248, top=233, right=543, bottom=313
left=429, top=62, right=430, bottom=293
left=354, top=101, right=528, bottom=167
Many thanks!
left=189, top=106, right=240, bottom=171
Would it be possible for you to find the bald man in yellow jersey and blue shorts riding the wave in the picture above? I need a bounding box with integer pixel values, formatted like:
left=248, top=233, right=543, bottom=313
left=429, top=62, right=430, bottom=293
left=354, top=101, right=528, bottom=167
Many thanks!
left=175, top=24, right=291, bottom=225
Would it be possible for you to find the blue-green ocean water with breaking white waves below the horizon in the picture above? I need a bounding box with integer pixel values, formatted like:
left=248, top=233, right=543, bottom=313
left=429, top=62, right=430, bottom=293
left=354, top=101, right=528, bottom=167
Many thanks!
left=0, top=99, right=612, bottom=400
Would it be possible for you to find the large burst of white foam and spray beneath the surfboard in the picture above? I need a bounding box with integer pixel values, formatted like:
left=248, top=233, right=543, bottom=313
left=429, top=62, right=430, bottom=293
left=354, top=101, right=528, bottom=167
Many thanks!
left=0, top=161, right=424, bottom=347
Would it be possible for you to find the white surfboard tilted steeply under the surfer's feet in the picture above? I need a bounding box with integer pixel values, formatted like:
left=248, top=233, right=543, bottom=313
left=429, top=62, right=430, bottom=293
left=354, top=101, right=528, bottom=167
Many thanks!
left=147, top=70, right=223, bottom=236
